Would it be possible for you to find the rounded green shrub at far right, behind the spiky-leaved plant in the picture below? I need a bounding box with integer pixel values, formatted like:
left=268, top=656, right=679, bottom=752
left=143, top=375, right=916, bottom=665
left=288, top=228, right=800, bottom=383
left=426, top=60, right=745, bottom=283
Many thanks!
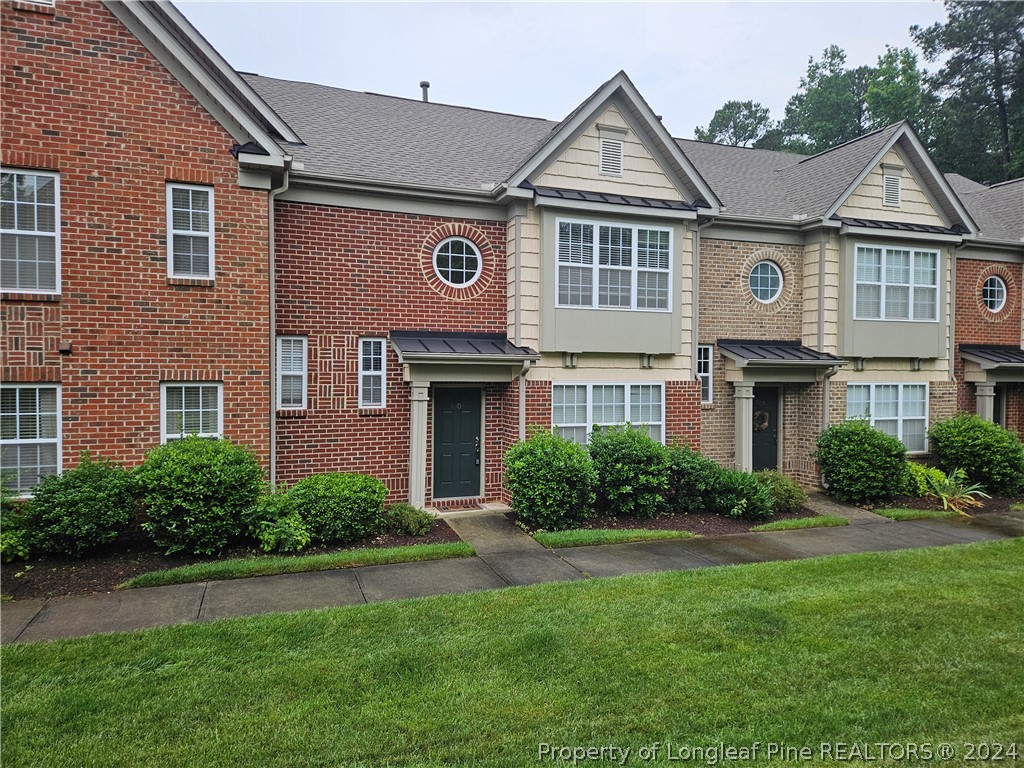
left=928, top=414, right=1024, bottom=496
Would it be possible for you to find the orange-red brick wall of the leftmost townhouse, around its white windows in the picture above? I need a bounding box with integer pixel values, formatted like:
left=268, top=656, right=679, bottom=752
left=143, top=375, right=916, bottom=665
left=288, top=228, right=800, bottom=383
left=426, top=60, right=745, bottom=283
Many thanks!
left=0, top=0, right=269, bottom=466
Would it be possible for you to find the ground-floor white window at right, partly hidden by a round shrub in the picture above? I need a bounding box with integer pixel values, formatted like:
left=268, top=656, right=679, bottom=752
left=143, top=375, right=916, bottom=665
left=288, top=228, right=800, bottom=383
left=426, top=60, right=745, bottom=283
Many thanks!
left=846, top=384, right=928, bottom=454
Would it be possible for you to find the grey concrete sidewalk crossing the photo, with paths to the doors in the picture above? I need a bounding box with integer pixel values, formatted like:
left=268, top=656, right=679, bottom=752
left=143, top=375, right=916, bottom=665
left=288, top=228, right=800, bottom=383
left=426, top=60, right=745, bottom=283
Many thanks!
left=0, top=505, right=1024, bottom=643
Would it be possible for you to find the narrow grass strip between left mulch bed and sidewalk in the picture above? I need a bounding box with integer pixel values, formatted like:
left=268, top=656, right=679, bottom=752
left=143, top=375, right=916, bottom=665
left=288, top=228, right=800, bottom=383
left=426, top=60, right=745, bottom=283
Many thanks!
left=120, top=542, right=476, bottom=589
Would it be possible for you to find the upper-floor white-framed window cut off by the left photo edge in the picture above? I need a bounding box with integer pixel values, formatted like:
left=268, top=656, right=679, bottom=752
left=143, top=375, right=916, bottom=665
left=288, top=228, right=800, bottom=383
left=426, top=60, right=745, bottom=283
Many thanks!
left=0, top=169, right=60, bottom=294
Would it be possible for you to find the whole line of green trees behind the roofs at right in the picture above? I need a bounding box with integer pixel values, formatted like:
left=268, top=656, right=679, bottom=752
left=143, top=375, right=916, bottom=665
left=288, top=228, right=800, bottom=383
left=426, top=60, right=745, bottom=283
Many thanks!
left=694, top=0, right=1024, bottom=183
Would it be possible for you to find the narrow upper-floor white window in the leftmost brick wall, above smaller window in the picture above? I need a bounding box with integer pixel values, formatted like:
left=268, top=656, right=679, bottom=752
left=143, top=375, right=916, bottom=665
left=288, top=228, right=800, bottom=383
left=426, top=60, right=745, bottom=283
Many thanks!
left=167, top=184, right=215, bottom=280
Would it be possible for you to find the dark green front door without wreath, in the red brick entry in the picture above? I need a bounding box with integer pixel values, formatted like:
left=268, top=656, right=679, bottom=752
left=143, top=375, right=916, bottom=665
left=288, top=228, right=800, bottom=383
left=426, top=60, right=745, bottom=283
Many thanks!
left=433, top=388, right=480, bottom=499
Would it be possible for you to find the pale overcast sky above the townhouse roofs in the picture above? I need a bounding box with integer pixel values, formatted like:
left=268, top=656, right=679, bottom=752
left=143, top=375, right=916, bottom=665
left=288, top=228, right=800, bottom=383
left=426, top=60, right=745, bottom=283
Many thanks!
left=175, top=0, right=945, bottom=138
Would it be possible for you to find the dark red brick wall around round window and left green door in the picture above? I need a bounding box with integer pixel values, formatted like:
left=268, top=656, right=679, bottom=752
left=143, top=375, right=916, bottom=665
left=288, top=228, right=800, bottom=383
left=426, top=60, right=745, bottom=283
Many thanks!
left=275, top=203, right=509, bottom=501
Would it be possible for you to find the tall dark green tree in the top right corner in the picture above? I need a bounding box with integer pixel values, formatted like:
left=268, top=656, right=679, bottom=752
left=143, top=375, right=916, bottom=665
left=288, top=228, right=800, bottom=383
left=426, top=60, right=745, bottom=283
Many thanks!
left=910, top=0, right=1024, bottom=179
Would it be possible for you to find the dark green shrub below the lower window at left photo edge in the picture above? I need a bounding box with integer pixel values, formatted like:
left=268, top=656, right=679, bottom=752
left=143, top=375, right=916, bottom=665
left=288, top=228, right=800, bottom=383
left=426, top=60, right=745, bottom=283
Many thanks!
left=22, top=452, right=135, bottom=557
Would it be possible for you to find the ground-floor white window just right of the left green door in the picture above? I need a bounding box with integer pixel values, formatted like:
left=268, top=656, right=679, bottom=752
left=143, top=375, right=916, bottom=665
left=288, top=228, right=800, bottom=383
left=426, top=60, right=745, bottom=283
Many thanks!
left=551, top=384, right=665, bottom=445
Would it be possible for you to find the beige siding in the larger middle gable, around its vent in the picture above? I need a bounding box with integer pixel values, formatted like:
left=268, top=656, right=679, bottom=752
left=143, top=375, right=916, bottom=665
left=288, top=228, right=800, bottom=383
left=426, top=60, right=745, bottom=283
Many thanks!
left=531, top=105, right=683, bottom=200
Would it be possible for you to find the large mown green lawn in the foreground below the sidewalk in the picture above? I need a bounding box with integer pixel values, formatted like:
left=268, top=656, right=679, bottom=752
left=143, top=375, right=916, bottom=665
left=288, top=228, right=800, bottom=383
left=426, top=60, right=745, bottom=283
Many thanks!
left=0, top=540, right=1024, bottom=768
